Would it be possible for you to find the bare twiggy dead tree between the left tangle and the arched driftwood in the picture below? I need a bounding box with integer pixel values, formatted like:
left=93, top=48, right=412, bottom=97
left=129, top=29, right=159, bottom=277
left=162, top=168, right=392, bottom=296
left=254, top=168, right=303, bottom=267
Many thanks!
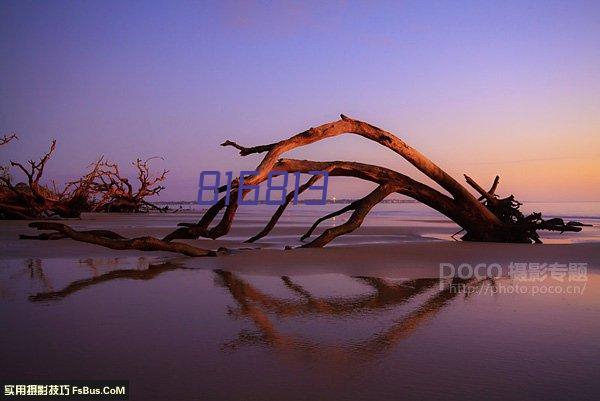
left=91, top=157, right=168, bottom=213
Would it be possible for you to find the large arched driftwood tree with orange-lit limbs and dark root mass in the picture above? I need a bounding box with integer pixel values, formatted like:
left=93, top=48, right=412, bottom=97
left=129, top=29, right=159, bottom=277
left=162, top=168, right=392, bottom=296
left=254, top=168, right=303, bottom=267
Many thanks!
left=24, top=115, right=582, bottom=255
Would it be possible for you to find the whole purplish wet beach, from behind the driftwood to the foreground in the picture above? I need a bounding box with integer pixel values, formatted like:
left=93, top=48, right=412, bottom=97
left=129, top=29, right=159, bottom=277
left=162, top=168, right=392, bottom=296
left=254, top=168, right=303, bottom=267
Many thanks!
left=0, top=213, right=600, bottom=400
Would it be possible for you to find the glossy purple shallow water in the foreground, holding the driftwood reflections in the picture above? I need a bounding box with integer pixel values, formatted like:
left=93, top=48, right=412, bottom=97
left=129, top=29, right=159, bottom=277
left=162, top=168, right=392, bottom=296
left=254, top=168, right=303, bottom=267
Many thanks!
left=0, top=258, right=600, bottom=400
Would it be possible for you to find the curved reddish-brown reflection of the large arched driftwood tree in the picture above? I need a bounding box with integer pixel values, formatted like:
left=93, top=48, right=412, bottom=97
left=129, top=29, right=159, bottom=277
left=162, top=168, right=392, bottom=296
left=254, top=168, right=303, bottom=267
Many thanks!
left=215, top=270, right=493, bottom=362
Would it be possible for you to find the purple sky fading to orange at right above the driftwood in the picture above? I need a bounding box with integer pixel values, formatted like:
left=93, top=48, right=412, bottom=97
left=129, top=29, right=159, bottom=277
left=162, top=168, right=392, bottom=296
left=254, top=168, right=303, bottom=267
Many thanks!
left=0, top=0, right=600, bottom=200
